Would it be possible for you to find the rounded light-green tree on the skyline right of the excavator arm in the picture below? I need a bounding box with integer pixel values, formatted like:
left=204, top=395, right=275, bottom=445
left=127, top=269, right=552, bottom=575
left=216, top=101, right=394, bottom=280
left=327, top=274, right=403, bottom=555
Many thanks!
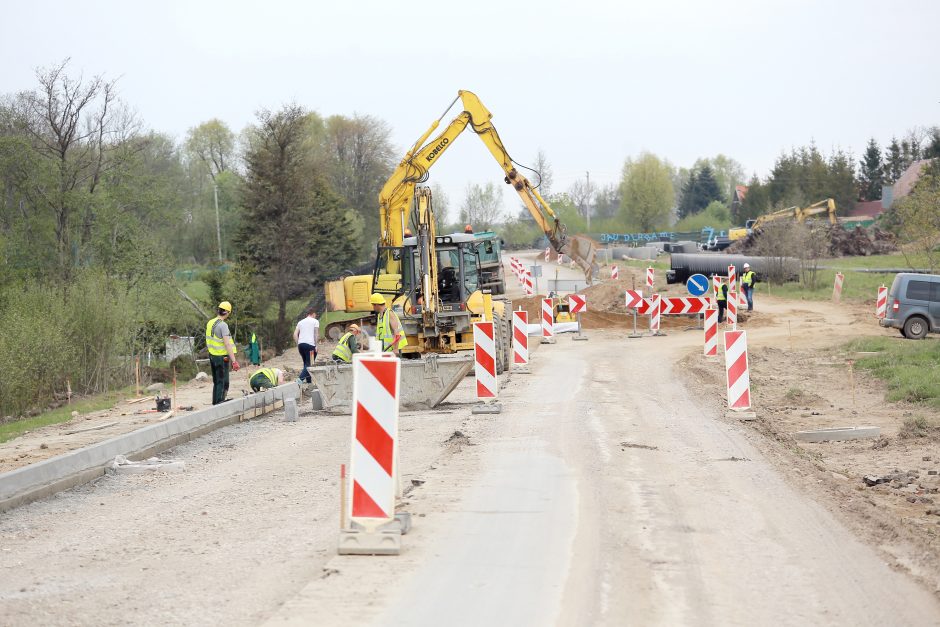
left=620, top=153, right=676, bottom=232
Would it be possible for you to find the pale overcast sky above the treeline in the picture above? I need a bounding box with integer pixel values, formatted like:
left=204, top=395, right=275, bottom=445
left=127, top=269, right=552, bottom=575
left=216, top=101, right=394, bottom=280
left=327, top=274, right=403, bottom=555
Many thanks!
left=0, top=0, right=940, bottom=216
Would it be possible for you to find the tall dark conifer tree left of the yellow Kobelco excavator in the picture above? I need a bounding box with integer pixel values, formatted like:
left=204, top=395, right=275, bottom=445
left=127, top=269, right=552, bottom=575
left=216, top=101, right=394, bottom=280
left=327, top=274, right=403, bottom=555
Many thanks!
left=236, top=105, right=362, bottom=350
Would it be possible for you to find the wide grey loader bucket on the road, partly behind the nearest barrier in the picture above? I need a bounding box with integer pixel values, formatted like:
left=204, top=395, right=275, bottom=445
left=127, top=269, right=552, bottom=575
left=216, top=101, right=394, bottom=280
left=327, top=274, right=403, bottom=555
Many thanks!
left=308, top=353, right=473, bottom=414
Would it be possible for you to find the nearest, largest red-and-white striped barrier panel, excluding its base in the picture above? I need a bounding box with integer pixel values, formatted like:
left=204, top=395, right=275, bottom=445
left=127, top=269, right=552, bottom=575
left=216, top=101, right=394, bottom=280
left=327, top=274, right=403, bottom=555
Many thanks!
left=347, top=353, right=401, bottom=528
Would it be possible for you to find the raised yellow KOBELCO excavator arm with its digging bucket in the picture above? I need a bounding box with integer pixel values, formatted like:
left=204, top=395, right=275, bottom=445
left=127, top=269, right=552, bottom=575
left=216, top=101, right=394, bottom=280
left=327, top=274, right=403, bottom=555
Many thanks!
left=379, top=91, right=597, bottom=281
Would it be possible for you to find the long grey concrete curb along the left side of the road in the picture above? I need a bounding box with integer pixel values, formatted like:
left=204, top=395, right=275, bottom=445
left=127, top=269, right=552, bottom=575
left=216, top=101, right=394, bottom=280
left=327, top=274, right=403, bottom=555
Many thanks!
left=0, top=383, right=300, bottom=512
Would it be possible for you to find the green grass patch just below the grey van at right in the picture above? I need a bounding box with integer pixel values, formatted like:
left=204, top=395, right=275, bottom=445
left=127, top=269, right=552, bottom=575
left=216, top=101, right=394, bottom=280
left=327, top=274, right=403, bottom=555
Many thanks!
left=846, top=337, right=940, bottom=408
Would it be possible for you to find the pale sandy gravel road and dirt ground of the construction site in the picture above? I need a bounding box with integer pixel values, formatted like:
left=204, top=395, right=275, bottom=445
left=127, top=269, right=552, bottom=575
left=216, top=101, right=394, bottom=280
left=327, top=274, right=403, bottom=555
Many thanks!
left=0, top=254, right=940, bottom=625
